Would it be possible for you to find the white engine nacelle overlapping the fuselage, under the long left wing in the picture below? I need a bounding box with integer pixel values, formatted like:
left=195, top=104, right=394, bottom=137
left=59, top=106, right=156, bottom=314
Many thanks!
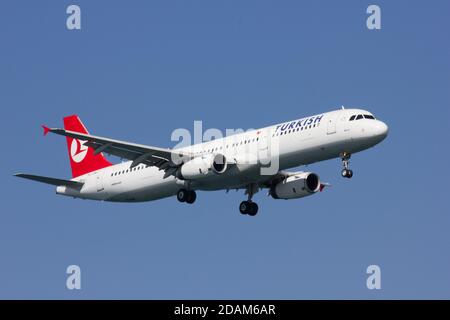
left=177, top=154, right=227, bottom=180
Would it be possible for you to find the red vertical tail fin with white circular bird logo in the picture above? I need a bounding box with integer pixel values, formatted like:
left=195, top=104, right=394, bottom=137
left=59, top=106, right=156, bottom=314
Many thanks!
left=64, top=115, right=112, bottom=178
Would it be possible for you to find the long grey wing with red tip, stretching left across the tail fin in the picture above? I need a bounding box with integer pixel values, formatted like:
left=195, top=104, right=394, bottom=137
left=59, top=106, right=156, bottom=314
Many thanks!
left=44, top=127, right=193, bottom=176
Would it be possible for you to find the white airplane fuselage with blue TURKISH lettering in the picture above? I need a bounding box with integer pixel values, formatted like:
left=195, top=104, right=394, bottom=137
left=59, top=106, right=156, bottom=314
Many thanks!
left=57, top=109, right=388, bottom=202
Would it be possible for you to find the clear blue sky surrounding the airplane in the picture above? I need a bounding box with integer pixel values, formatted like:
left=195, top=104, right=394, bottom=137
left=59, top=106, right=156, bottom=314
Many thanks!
left=0, top=0, right=450, bottom=299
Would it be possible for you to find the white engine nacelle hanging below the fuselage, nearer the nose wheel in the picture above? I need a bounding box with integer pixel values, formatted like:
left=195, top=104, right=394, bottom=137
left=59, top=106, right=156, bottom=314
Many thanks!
left=270, top=172, right=320, bottom=199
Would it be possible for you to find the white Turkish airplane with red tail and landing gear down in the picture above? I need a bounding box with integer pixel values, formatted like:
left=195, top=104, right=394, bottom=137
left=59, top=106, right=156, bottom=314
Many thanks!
left=15, top=107, right=389, bottom=216
